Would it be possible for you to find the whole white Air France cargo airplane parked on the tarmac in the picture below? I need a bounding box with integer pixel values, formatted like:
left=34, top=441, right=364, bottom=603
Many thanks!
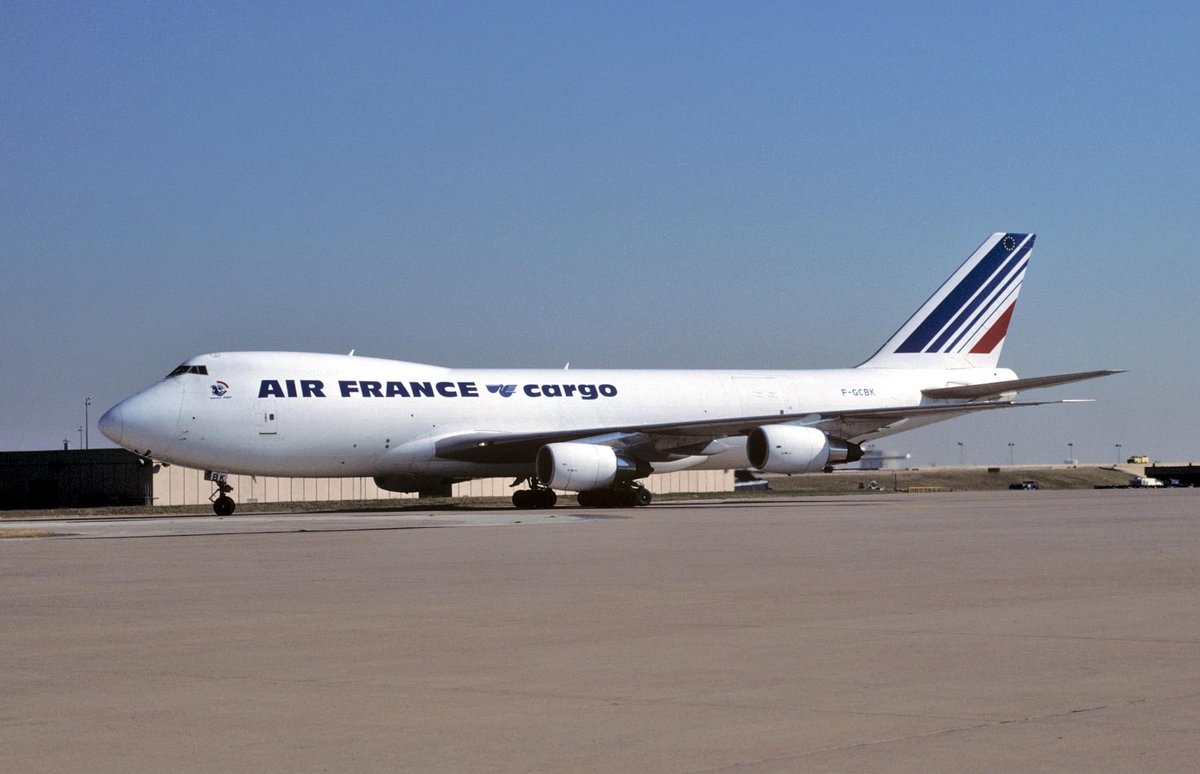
left=100, top=233, right=1120, bottom=516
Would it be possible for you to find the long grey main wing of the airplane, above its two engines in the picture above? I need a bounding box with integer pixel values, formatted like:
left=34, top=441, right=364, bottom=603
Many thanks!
left=434, top=401, right=1078, bottom=463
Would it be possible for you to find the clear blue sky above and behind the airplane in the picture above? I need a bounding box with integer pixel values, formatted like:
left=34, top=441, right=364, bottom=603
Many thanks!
left=0, top=1, right=1200, bottom=464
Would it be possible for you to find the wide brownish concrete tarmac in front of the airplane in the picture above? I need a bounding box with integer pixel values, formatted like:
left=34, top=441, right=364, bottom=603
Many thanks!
left=0, top=490, right=1200, bottom=772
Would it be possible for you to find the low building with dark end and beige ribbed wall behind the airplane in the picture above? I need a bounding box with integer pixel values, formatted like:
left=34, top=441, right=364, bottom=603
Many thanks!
left=0, top=449, right=733, bottom=510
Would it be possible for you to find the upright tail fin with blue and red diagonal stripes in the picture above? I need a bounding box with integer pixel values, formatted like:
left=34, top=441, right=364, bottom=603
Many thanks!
left=859, top=233, right=1034, bottom=368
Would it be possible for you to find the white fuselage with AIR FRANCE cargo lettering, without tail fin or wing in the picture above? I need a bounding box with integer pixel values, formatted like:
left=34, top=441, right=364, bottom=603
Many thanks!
left=101, top=352, right=1015, bottom=478
